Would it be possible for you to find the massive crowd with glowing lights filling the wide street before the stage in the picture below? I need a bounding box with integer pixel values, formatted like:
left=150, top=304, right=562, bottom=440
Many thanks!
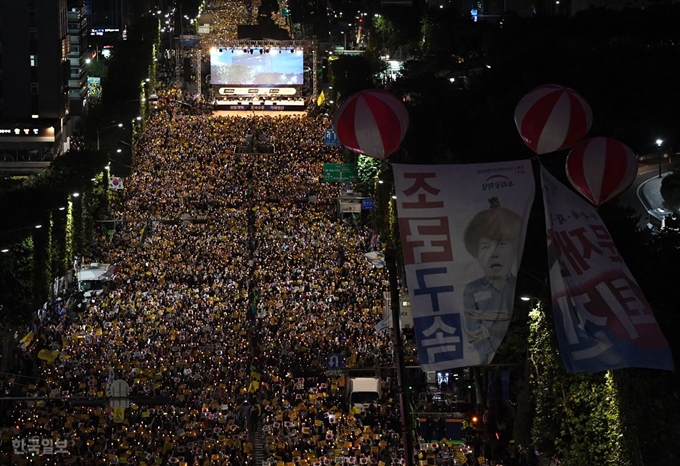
left=1, top=95, right=478, bottom=466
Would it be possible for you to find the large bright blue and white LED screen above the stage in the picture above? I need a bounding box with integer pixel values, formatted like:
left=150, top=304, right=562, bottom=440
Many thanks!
left=210, top=47, right=303, bottom=86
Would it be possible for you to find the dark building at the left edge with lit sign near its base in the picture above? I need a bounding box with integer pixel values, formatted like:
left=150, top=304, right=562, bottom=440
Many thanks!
left=0, top=0, right=71, bottom=173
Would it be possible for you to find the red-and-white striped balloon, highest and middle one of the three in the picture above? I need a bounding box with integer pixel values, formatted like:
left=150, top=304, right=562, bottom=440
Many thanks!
left=515, top=84, right=593, bottom=154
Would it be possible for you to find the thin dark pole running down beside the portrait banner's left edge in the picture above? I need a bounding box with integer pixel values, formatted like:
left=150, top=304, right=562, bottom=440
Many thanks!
left=385, top=248, right=414, bottom=466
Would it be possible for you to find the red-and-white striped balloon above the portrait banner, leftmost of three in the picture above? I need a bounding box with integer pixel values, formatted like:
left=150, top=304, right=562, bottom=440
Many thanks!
left=333, top=89, right=409, bottom=159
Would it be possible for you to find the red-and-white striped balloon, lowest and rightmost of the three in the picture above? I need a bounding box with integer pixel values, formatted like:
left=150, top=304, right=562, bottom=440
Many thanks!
left=566, top=137, right=638, bottom=206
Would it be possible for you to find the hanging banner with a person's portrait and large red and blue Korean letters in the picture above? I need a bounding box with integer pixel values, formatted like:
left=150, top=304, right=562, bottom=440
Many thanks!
left=393, top=160, right=535, bottom=371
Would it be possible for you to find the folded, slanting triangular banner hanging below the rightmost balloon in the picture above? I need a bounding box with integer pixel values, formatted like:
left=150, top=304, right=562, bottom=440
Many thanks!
left=541, top=168, right=673, bottom=372
